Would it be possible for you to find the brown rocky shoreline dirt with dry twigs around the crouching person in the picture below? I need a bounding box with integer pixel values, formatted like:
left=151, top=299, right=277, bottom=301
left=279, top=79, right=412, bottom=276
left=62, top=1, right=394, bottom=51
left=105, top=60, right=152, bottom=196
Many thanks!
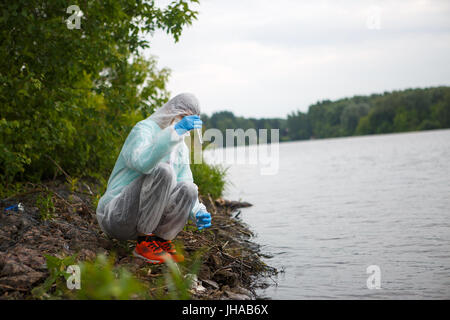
left=0, top=180, right=277, bottom=300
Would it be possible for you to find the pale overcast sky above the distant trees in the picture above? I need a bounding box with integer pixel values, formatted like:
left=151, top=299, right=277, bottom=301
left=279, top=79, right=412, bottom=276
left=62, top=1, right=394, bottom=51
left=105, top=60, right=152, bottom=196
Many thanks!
left=146, top=0, right=450, bottom=118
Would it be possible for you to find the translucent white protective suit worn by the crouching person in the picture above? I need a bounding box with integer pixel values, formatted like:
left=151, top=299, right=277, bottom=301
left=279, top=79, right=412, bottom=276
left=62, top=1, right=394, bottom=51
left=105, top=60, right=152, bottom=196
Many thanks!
left=97, top=93, right=206, bottom=240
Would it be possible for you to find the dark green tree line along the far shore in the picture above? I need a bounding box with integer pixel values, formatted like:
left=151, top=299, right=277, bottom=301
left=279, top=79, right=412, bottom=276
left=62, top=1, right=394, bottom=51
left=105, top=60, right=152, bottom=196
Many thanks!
left=202, top=87, right=450, bottom=141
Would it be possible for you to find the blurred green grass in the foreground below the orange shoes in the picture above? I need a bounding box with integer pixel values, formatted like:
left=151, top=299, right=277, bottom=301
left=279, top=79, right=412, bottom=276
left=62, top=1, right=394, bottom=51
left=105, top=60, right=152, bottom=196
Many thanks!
left=31, top=251, right=206, bottom=300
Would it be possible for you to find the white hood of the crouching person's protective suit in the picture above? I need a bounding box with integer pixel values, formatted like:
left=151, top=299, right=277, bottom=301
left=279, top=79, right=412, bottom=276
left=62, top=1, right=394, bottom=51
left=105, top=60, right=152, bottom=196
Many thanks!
left=149, top=93, right=200, bottom=129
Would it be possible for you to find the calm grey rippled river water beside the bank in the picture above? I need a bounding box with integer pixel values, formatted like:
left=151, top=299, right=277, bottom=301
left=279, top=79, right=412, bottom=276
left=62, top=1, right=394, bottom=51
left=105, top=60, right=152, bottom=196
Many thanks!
left=205, top=130, right=450, bottom=299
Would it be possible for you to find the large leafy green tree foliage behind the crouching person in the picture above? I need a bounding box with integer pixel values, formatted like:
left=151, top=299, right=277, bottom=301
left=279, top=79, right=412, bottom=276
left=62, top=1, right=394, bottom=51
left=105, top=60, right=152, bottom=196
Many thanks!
left=0, top=0, right=198, bottom=182
